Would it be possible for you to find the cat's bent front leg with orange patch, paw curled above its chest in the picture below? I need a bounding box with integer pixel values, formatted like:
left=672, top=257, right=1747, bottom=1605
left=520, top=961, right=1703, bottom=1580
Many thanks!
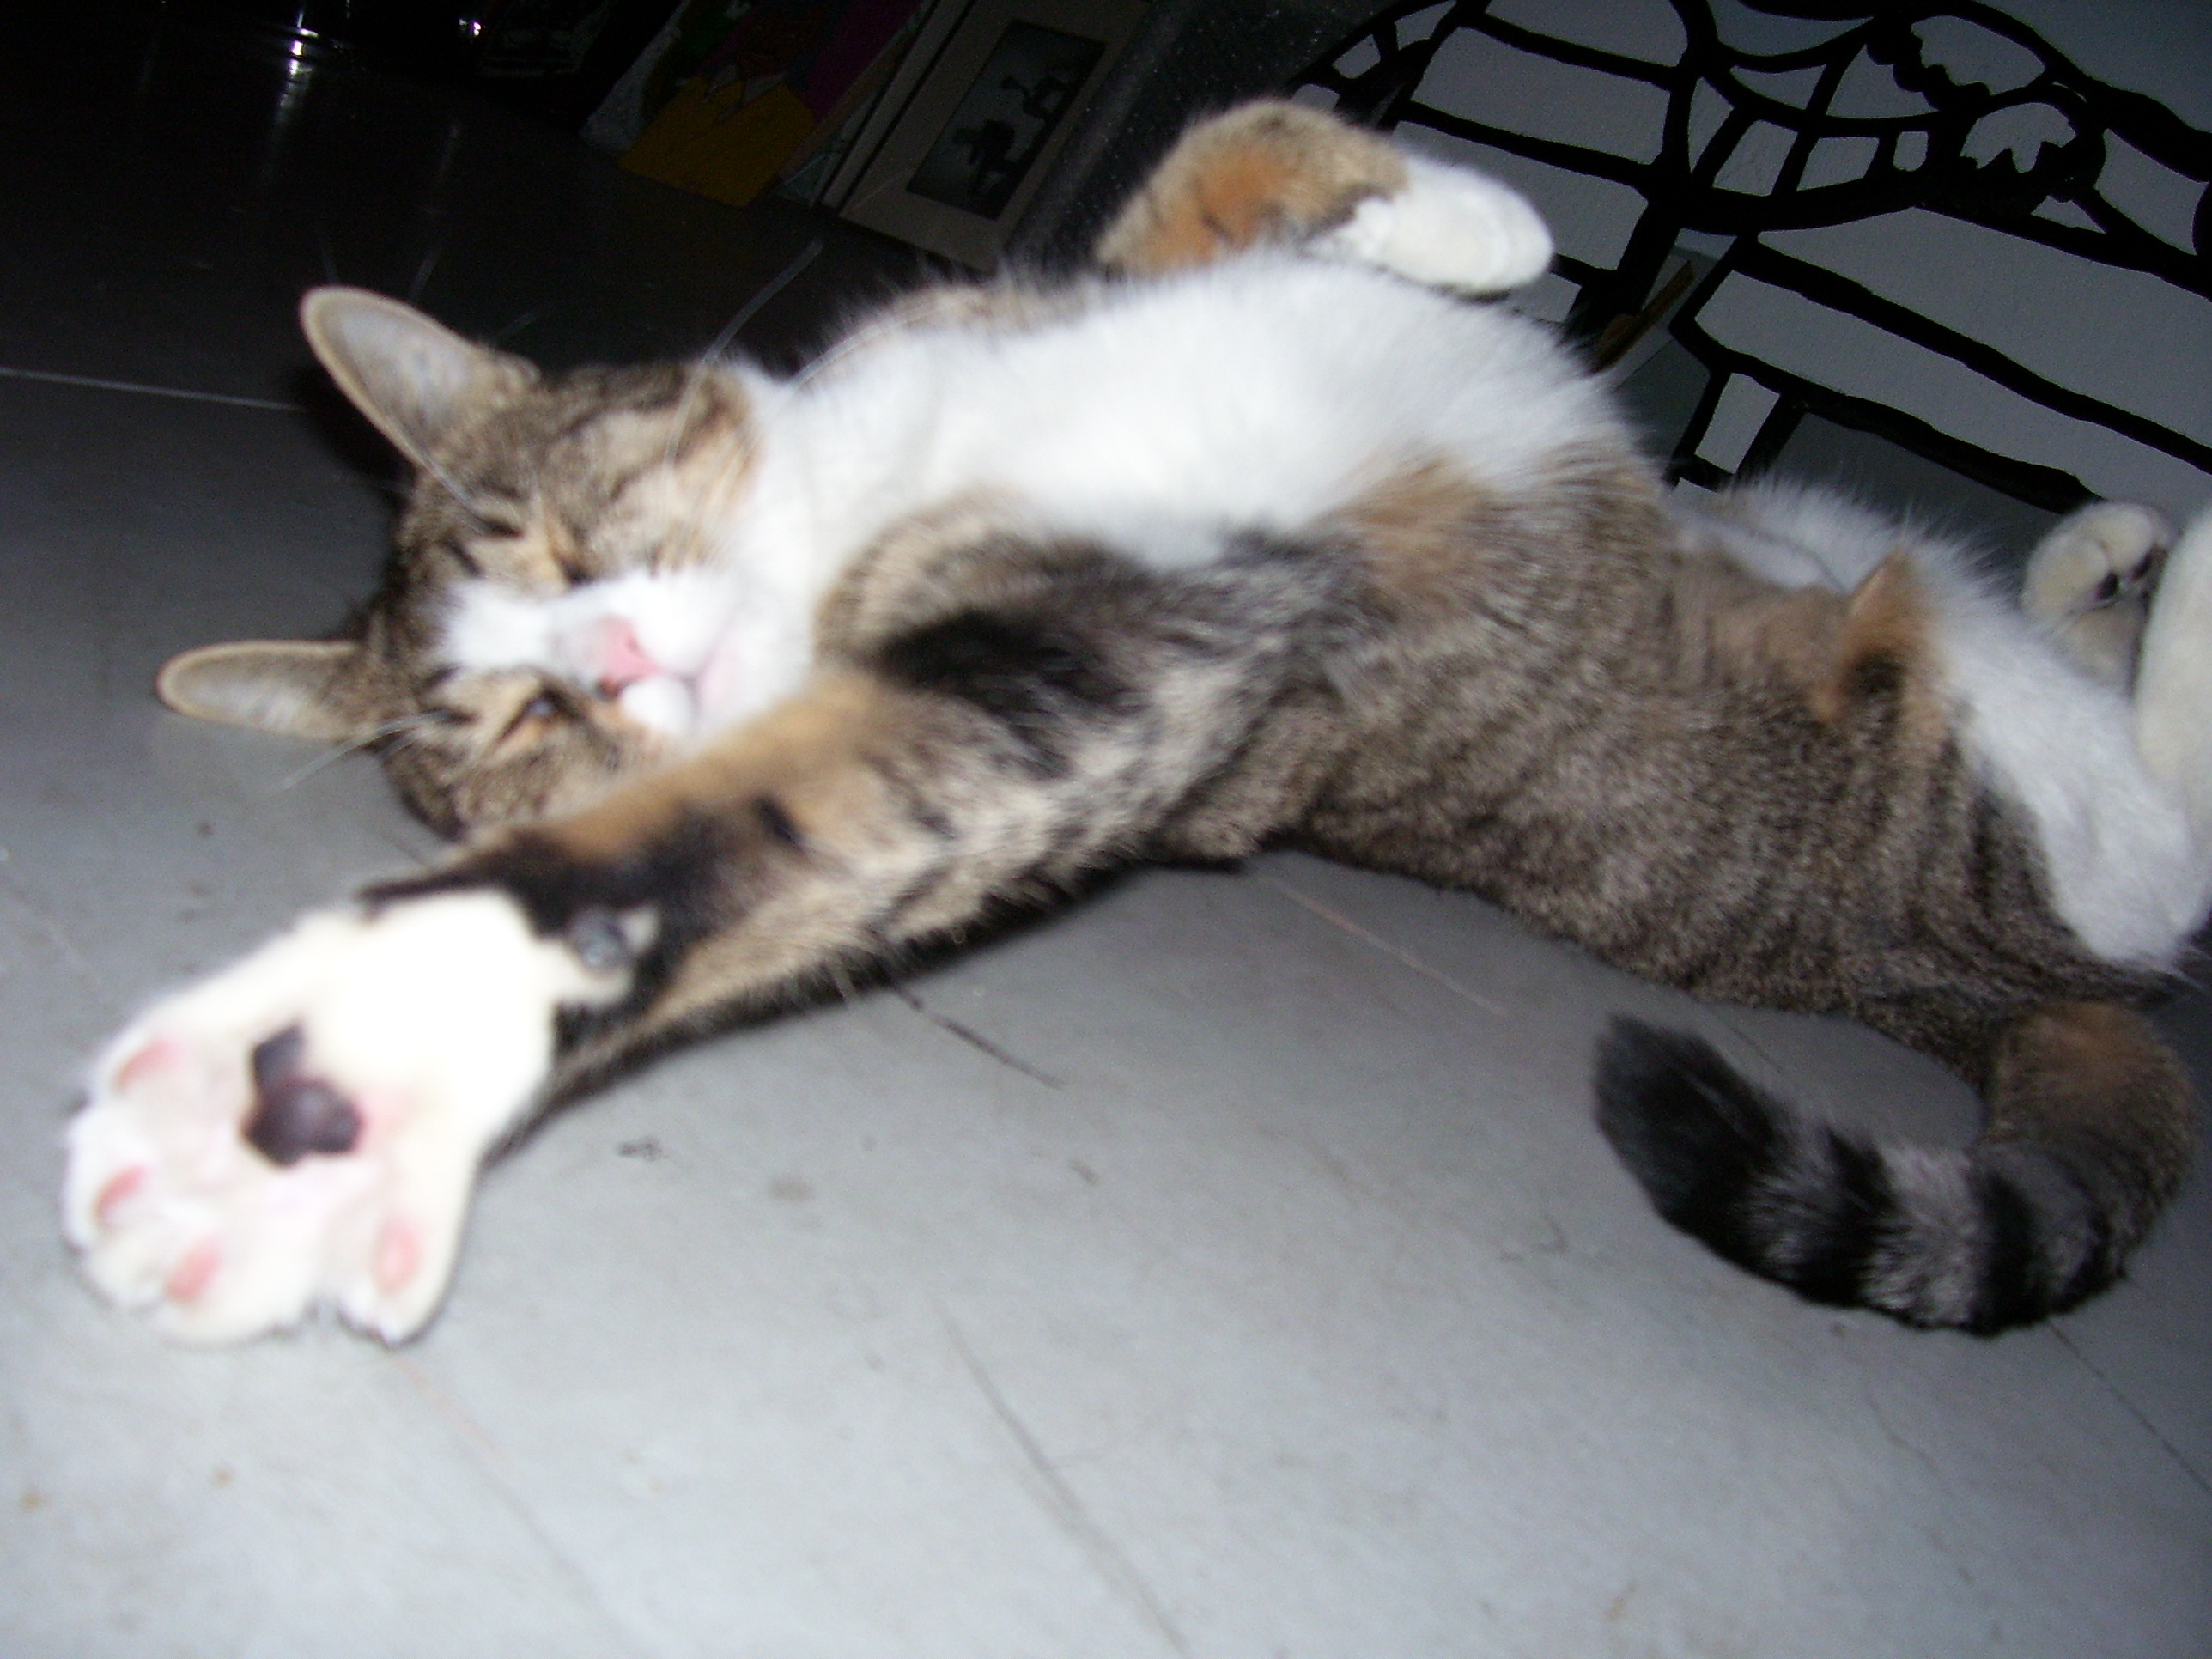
left=1095, top=101, right=1551, bottom=295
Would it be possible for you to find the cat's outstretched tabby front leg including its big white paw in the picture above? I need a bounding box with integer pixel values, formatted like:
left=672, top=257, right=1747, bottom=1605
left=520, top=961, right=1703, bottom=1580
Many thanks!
left=64, top=555, right=1301, bottom=1343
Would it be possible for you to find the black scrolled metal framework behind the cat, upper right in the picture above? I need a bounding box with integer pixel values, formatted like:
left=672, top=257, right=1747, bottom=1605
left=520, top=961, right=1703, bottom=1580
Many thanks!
left=1294, top=0, right=2212, bottom=511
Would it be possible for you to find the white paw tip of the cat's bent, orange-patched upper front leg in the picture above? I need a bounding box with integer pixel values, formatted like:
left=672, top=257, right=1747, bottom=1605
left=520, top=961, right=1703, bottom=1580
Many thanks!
left=1314, top=155, right=1551, bottom=295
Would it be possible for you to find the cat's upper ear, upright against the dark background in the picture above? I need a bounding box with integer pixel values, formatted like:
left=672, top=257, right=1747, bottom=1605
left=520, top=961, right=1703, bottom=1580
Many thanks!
left=299, top=288, right=538, bottom=469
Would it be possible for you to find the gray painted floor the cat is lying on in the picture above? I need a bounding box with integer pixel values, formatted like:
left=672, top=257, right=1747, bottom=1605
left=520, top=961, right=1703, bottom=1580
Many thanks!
left=0, top=7, right=2212, bottom=1659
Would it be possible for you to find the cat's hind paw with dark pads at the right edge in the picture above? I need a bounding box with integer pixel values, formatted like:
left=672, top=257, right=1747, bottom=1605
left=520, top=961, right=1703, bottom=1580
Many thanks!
left=2020, top=502, right=2174, bottom=690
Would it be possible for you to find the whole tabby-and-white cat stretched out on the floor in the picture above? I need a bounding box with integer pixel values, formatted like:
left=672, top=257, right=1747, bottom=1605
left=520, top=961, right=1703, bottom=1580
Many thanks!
left=64, top=104, right=2212, bottom=1340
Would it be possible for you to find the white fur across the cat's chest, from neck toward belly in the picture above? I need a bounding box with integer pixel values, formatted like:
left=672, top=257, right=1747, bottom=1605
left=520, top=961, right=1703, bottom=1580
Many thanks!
left=734, top=254, right=1620, bottom=592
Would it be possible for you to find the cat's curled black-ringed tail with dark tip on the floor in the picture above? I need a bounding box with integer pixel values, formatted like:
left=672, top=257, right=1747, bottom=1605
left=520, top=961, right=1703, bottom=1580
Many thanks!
left=1597, top=1002, right=2194, bottom=1336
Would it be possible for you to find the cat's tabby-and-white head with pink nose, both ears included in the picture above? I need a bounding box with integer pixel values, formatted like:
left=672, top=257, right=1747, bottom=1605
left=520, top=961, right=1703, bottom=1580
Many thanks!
left=159, top=288, right=754, bottom=834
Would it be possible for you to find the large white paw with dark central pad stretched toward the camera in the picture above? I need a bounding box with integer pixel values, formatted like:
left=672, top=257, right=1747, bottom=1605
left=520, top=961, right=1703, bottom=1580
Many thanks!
left=62, top=891, right=608, bottom=1343
